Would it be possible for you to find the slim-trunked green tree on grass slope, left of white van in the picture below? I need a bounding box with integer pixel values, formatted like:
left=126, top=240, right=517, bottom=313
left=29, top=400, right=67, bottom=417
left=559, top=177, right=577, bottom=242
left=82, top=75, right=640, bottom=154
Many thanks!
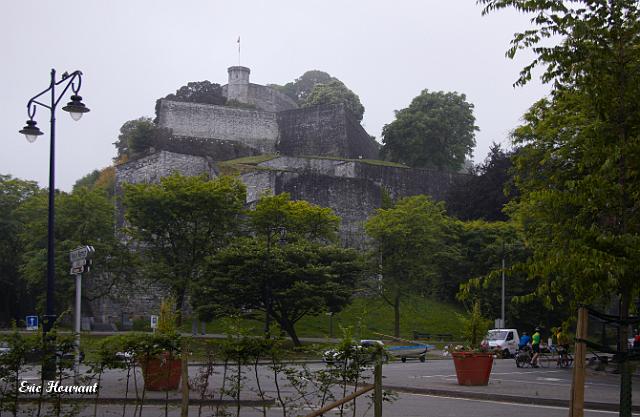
left=365, top=196, right=457, bottom=337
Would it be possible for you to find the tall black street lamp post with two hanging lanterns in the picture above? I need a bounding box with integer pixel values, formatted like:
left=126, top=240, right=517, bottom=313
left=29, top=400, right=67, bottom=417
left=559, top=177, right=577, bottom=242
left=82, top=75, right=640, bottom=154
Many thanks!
left=20, top=69, right=89, bottom=380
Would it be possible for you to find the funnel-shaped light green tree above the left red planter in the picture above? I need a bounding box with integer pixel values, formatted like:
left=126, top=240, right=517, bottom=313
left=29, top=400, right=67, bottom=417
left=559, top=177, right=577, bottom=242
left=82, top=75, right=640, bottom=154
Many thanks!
left=124, top=174, right=246, bottom=320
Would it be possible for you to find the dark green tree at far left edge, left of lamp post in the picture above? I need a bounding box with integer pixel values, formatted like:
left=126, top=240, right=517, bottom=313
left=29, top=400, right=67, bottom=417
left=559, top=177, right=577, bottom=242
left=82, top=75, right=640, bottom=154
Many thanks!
left=0, top=175, right=40, bottom=327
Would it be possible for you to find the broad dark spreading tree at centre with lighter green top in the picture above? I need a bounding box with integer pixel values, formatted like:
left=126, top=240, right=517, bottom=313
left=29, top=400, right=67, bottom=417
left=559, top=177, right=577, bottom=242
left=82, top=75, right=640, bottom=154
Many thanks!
left=194, top=193, right=362, bottom=345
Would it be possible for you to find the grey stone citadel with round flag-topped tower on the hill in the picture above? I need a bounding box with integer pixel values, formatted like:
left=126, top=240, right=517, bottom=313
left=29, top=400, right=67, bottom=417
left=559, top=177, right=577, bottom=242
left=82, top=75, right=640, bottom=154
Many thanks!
left=92, top=66, right=461, bottom=322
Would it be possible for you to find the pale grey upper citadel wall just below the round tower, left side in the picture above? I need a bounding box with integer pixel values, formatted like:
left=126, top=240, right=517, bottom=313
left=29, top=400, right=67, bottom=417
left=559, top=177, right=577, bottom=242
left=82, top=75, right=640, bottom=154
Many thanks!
left=158, top=100, right=278, bottom=153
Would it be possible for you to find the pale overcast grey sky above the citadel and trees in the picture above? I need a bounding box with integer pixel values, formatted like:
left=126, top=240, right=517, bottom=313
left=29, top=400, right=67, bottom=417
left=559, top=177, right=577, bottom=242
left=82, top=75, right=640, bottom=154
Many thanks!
left=0, top=0, right=549, bottom=191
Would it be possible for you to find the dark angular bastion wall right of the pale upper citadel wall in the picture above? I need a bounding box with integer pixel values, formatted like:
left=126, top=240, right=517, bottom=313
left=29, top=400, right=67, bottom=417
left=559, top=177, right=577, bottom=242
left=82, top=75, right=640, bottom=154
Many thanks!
left=278, top=104, right=378, bottom=159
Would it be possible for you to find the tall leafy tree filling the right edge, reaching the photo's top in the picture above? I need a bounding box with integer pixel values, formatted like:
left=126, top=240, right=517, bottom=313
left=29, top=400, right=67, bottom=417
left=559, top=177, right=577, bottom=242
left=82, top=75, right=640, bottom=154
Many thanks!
left=479, top=0, right=640, bottom=410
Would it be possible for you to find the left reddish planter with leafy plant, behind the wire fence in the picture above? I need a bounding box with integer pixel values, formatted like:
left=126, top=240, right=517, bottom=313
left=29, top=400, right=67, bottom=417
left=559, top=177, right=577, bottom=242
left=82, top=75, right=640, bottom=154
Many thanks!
left=135, top=300, right=182, bottom=391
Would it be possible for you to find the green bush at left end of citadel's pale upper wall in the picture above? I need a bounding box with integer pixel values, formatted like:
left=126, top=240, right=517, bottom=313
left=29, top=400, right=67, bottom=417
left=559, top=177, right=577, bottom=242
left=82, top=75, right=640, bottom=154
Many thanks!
left=113, top=117, right=171, bottom=161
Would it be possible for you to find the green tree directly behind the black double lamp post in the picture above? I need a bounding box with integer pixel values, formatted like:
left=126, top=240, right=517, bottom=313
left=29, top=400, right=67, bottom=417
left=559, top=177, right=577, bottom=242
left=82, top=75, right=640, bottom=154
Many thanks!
left=16, top=187, right=130, bottom=311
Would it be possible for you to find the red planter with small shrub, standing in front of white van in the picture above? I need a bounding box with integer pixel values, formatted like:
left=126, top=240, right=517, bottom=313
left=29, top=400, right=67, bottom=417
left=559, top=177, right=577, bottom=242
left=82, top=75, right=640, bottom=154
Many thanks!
left=451, top=301, right=493, bottom=385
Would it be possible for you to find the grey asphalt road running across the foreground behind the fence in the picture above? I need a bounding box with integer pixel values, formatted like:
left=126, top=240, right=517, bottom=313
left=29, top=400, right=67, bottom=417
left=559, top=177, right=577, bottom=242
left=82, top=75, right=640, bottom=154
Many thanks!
left=10, top=360, right=640, bottom=417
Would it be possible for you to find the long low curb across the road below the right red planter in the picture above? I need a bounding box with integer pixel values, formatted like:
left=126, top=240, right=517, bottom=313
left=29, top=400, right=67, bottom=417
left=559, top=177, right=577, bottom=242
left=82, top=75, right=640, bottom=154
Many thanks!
left=382, top=385, right=640, bottom=413
